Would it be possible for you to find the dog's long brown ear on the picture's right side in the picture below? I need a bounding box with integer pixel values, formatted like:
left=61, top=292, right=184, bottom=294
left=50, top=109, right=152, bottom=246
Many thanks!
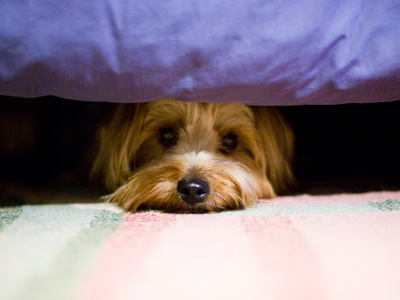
left=252, top=106, right=294, bottom=193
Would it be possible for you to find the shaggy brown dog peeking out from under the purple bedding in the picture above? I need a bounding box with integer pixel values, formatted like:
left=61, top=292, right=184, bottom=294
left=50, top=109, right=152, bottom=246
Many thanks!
left=93, top=99, right=294, bottom=213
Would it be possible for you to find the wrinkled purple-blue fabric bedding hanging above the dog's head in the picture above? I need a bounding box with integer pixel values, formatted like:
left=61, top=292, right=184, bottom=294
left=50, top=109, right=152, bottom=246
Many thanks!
left=0, top=0, right=400, bottom=105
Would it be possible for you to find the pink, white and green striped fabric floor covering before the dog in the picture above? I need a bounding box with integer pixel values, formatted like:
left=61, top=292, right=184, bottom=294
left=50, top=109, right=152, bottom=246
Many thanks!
left=0, top=192, right=400, bottom=300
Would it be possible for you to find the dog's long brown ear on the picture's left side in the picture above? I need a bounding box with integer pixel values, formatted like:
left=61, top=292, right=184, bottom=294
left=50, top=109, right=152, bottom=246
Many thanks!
left=92, top=103, right=147, bottom=190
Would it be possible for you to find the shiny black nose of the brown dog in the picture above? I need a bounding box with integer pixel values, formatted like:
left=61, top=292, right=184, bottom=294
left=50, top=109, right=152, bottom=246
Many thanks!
left=178, top=177, right=210, bottom=204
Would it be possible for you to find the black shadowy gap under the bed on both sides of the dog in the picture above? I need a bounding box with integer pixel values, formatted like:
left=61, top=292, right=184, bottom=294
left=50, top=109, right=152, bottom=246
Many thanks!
left=0, top=97, right=400, bottom=205
